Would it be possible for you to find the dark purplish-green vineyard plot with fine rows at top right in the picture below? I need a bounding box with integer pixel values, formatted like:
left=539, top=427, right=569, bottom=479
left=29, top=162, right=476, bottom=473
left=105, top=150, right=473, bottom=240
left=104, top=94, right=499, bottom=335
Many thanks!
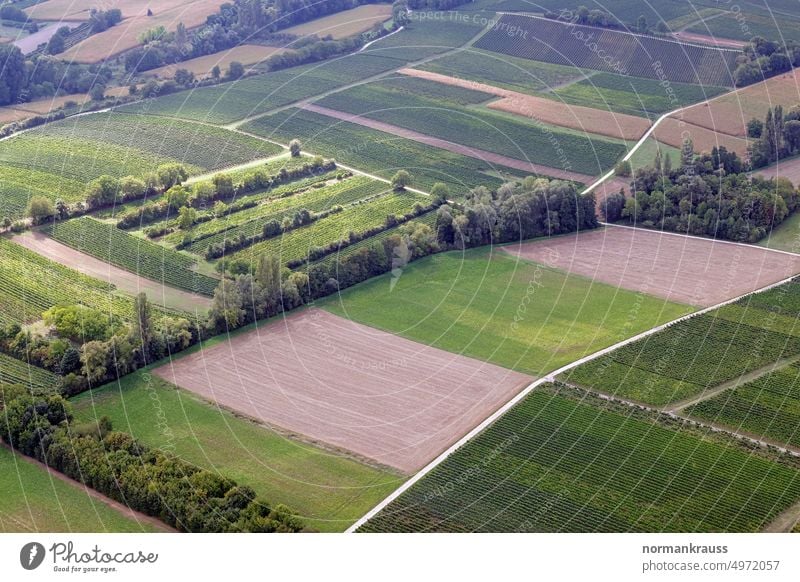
left=475, top=14, right=739, bottom=87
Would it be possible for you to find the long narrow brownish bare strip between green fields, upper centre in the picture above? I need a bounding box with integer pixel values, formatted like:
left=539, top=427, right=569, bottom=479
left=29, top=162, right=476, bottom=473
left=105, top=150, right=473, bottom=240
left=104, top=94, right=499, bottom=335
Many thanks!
left=302, top=103, right=595, bottom=184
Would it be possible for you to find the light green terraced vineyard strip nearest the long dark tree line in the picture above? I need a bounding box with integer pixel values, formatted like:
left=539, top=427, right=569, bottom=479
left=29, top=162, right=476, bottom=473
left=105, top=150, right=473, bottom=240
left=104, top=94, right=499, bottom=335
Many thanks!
left=228, top=192, right=430, bottom=264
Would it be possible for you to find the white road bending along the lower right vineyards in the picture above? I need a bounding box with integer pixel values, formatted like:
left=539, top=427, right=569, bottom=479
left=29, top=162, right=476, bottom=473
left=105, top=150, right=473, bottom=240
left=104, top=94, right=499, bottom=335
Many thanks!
left=345, top=275, right=795, bottom=533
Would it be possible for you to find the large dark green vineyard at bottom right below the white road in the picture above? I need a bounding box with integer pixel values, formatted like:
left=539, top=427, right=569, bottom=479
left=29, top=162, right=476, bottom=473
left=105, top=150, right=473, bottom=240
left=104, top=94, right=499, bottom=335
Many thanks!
left=359, top=385, right=800, bottom=532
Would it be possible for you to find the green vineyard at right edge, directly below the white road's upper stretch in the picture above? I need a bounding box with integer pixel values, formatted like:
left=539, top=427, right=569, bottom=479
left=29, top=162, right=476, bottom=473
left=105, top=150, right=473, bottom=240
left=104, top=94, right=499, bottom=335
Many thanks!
left=564, top=282, right=800, bottom=406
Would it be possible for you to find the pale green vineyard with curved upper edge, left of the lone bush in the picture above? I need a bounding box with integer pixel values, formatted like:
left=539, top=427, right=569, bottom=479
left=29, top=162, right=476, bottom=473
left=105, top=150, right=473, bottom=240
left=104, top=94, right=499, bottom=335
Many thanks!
left=42, top=111, right=282, bottom=171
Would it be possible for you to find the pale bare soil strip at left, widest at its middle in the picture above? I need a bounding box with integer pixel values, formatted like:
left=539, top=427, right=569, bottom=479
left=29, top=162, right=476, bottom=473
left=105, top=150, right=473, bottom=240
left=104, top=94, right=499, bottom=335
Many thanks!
left=12, top=231, right=211, bottom=314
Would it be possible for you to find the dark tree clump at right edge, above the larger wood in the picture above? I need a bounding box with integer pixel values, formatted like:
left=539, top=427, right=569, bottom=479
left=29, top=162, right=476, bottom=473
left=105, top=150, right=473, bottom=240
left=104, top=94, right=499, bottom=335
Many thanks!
left=747, top=105, right=800, bottom=168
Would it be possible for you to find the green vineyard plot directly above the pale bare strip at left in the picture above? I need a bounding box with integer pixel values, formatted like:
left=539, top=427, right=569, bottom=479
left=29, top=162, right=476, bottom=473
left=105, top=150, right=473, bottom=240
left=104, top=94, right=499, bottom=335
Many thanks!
left=49, top=216, right=218, bottom=295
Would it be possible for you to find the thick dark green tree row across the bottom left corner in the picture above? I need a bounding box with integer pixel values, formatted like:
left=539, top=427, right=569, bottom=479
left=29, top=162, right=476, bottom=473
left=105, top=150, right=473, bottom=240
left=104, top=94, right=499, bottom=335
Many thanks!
left=0, top=385, right=303, bottom=532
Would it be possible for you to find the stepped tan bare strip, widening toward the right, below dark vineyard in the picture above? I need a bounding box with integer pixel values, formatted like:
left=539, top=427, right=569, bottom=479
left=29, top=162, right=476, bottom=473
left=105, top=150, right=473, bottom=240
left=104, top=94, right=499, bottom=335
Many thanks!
left=400, top=69, right=650, bottom=141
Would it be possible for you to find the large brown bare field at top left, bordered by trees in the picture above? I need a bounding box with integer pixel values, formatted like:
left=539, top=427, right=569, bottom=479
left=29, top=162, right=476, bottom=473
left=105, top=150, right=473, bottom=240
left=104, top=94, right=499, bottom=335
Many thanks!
left=59, top=0, right=226, bottom=63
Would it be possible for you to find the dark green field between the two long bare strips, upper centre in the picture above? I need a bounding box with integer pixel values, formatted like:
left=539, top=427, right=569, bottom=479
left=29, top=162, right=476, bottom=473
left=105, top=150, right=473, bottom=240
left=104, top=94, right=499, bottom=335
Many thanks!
left=320, top=83, right=625, bottom=175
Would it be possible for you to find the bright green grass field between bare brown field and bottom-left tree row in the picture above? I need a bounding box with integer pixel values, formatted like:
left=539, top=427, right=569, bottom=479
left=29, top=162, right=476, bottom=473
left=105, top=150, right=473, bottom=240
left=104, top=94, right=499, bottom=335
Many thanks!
left=73, top=372, right=403, bottom=531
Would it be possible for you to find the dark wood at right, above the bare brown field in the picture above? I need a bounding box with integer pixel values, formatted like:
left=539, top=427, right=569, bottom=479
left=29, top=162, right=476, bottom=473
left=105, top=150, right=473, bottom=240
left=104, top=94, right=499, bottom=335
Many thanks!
left=605, top=147, right=800, bottom=242
